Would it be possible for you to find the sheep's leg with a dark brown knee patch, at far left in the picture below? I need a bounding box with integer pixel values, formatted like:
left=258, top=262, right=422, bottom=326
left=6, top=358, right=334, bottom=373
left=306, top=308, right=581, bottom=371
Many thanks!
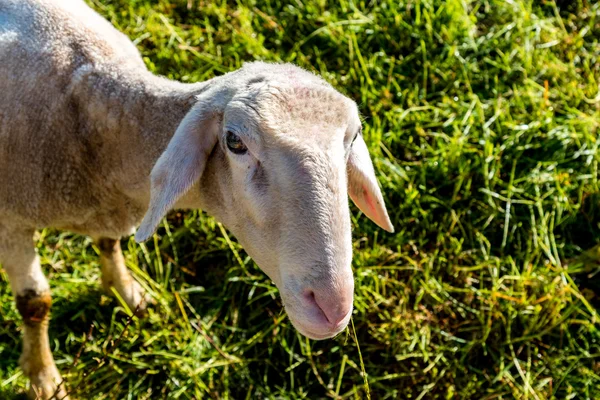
left=0, top=225, right=67, bottom=400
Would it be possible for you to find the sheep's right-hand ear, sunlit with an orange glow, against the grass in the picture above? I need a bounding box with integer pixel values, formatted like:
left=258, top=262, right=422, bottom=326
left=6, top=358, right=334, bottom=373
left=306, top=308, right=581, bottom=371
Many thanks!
left=347, top=134, right=394, bottom=232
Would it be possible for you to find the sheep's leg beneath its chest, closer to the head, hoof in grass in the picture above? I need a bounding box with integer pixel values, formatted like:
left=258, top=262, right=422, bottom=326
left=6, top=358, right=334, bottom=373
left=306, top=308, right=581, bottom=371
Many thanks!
left=96, top=238, right=150, bottom=315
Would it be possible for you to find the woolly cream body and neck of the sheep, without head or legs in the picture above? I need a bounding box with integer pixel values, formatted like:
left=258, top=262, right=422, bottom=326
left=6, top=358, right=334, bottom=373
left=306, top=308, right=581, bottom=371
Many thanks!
left=0, top=0, right=201, bottom=238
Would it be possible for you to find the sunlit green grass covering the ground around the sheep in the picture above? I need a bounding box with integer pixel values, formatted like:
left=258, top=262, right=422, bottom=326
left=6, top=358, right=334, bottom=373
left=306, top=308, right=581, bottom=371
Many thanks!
left=0, top=0, right=600, bottom=400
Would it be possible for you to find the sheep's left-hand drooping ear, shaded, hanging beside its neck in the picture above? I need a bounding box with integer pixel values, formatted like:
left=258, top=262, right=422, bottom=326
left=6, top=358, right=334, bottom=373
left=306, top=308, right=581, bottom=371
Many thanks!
left=135, top=102, right=220, bottom=243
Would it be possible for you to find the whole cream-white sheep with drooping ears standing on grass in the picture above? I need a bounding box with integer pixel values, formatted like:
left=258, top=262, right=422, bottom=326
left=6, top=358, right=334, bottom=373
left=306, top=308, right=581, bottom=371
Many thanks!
left=0, top=0, right=393, bottom=399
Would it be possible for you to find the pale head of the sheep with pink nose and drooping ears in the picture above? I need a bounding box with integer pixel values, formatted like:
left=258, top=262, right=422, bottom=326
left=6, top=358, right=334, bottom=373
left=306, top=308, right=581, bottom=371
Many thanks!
left=138, top=65, right=392, bottom=339
